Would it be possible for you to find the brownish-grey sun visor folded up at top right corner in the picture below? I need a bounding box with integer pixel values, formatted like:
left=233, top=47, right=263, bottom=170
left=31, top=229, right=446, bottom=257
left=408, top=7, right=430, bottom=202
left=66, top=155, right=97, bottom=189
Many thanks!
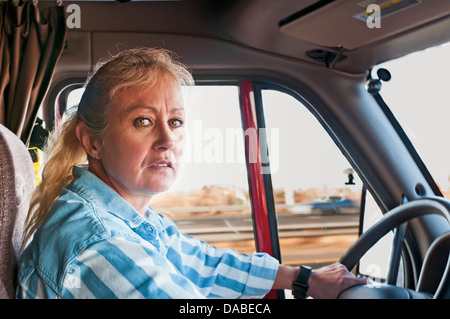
left=279, top=0, right=450, bottom=50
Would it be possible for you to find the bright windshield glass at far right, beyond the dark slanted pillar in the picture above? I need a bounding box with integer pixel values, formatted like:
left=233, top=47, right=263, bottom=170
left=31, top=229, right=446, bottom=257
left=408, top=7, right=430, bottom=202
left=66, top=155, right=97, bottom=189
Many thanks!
left=375, top=43, right=450, bottom=199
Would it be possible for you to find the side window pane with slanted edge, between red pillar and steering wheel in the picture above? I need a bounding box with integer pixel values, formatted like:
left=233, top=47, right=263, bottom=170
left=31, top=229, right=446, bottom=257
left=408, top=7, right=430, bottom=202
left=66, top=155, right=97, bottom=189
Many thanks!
left=262, top=90, right=362, bottom=268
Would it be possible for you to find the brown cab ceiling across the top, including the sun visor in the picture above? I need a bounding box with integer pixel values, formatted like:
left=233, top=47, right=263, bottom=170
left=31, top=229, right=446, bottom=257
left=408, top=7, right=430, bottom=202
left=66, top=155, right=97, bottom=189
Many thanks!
left=47, top=0, right=450, bottom=73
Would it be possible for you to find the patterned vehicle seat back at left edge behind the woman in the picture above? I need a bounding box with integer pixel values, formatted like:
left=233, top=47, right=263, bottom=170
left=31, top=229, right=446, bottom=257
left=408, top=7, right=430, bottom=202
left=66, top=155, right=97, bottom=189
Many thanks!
left=0, top=124, right=36, bottom=299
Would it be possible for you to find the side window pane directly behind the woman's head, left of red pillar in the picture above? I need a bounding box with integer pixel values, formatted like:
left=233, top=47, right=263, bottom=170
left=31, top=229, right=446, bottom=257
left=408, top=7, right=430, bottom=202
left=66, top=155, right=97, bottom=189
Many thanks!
left=67, top=85, right=255, bottom=253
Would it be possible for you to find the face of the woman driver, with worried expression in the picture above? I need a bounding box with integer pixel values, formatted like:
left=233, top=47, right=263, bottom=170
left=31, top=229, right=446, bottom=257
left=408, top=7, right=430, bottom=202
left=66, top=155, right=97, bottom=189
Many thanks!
left=94, top=74, right=185, bottom=208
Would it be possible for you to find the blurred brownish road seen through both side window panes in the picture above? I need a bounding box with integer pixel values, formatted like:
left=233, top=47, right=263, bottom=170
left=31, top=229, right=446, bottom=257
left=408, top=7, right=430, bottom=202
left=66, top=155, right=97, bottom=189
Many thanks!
left=173, top=212, right=359, bottom=267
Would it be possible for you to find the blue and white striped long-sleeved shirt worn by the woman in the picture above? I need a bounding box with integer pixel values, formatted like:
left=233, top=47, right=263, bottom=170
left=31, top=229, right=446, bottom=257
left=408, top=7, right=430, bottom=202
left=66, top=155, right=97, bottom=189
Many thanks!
left=17, top=167, right=279, bottom=299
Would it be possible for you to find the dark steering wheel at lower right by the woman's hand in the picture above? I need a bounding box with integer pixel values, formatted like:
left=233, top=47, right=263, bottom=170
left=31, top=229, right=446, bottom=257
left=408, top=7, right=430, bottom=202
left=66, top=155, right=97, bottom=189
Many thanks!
left=338, top=199, right=450, bottom=299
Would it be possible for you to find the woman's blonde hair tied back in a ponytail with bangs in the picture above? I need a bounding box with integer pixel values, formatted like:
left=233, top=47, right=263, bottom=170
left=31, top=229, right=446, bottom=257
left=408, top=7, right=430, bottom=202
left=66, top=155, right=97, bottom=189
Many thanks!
left=23, top=48, right=194, bottom=246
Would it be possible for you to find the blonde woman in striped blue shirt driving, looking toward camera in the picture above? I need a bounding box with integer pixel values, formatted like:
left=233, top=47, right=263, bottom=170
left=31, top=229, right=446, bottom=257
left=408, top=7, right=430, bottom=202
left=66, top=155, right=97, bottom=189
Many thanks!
left=18, top=49, right=365, bottom=298
